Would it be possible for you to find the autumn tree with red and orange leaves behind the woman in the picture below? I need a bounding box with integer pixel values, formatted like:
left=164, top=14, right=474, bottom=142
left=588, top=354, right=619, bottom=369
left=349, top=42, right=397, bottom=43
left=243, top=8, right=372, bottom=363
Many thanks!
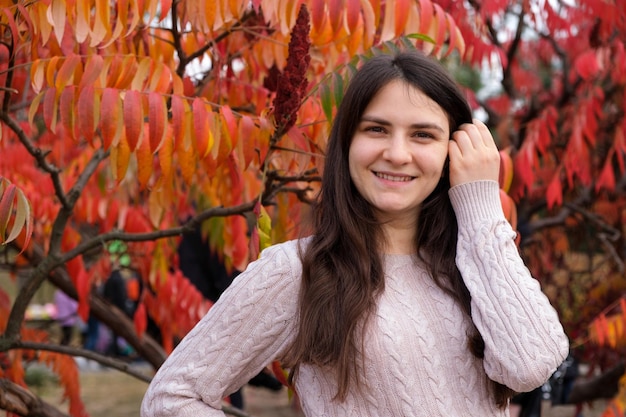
left=0, top=0, right=626, bottom=416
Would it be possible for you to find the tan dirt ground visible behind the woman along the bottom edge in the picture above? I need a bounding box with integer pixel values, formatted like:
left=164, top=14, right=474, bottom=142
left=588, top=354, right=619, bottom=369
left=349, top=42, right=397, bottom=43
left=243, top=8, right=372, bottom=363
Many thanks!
left=39, top=360, right=605, bottom=417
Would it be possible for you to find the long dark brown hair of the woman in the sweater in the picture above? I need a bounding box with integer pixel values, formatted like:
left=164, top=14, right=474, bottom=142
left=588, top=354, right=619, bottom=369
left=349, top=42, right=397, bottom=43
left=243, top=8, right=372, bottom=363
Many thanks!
left=285, top=51, right=512, bottom=407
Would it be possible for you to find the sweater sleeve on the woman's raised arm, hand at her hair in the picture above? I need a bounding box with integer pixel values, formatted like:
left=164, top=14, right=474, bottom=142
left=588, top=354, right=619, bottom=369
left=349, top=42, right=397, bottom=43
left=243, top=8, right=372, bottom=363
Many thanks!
left=449, top=181, right=569, bottom=392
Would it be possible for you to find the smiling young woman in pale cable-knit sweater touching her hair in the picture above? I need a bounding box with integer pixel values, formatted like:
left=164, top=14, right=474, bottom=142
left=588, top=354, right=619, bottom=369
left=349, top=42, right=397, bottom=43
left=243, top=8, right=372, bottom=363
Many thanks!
left=142, top=52, right=568, bottom=417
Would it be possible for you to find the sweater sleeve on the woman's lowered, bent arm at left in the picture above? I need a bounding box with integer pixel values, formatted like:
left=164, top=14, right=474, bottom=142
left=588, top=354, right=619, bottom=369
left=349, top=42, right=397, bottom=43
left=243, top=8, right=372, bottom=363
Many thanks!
left=141, top=245, right=300, bottom=417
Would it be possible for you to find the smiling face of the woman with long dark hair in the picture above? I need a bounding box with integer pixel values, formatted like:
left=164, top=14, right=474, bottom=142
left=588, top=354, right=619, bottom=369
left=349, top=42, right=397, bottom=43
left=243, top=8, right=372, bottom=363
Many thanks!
left=348, top=80, right=450, bottom=223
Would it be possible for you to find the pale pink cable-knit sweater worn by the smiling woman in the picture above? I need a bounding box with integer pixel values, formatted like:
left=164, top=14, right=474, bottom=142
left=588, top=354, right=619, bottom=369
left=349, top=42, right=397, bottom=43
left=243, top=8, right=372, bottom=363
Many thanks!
left=141, top=181, right=568, bottom=417
